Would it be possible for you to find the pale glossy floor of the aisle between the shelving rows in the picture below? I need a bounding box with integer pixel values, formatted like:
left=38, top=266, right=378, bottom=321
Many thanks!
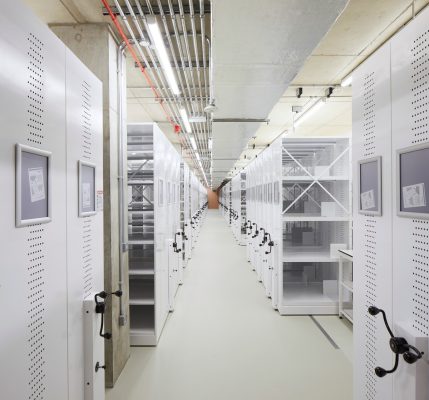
left=107, top=210, right=352, bottom=400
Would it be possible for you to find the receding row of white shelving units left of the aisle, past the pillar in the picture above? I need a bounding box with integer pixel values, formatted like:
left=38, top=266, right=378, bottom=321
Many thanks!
left=127, top=123, right=206, bottom=346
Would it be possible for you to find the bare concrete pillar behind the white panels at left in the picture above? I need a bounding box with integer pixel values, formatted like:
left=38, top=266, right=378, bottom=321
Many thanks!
left=50, top=24, right=130, bottom=387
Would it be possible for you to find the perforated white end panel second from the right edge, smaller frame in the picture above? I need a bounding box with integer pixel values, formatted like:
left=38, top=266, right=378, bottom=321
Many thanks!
left=352, top=45, right=393, bottom=400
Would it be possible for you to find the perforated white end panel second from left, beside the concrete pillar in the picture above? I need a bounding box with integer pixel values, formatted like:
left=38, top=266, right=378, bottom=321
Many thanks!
left=66, top=50, right=104, bottom=400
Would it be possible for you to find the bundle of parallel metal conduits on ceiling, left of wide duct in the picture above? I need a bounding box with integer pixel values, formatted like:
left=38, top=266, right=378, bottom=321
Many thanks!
left=102, top=0, right=213, bottom=185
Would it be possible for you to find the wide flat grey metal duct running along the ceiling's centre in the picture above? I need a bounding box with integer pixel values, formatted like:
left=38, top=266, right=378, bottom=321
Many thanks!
left=212, top=0, right=347, bottom=187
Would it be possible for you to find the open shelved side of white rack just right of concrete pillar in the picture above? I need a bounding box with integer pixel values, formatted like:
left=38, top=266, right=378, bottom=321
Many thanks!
left=127, top=127, right=157, bottom=345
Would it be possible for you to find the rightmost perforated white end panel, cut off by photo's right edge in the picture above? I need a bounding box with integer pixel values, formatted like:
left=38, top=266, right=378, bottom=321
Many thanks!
left=391, top=10, right=429, bottom=400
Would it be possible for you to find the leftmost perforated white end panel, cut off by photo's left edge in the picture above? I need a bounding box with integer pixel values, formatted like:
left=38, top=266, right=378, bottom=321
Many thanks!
left=0, top=0, right=67, bottom=400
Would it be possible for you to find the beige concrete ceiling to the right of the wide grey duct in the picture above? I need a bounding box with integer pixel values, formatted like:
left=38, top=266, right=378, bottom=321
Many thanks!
left=224, top=0, right=429, bottom=181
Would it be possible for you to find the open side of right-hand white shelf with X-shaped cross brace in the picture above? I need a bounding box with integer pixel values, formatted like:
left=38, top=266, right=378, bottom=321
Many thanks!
left=278, top=138, right=351, bottom=314
